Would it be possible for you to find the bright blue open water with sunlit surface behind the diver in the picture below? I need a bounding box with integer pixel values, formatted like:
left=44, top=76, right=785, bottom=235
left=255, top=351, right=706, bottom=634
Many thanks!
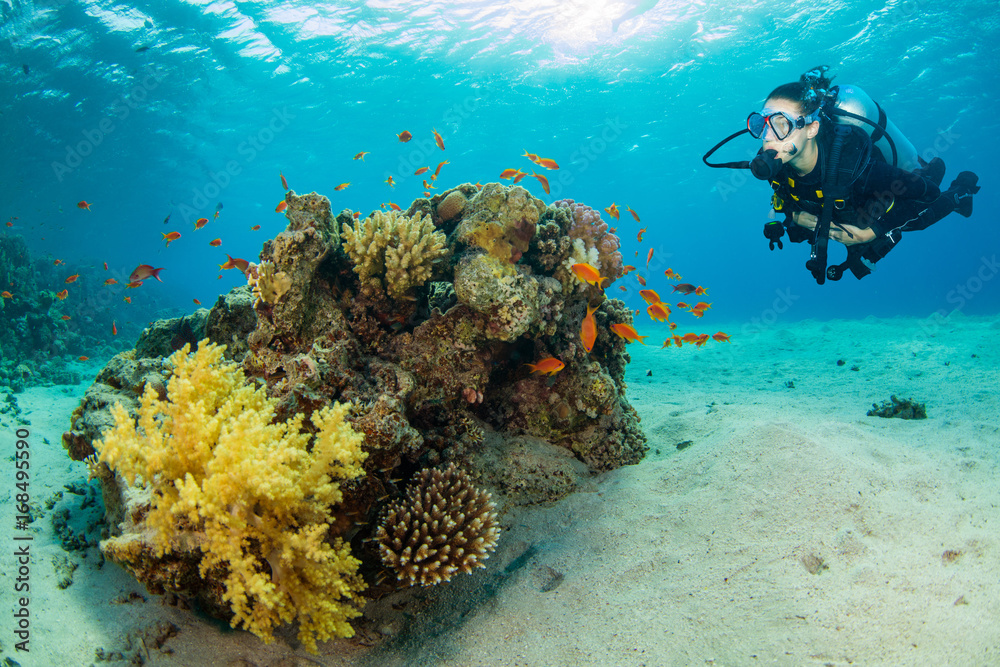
left=0, top=0, right=1000, bottom=330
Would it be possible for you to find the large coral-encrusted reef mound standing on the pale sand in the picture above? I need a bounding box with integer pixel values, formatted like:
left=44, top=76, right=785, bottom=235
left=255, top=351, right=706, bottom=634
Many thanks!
left=72, top=183, right=646, bottom=641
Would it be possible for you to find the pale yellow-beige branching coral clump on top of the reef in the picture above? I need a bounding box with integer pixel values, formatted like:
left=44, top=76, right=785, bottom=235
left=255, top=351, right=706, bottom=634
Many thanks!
left=341, top=211, right=448, bottom=299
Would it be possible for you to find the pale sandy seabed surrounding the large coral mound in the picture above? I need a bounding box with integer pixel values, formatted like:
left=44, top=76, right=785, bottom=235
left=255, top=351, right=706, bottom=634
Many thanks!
left=0, top=314, right=1000, bottom=667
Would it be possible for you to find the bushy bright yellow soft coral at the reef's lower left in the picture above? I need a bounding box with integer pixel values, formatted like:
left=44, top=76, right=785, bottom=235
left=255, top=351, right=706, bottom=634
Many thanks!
left=94, top=340, right=367, bottom=652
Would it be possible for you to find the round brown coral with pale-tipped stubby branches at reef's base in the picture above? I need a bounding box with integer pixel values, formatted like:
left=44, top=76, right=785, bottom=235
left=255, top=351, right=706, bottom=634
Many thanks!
left=375, top=463, right=500, bottom=586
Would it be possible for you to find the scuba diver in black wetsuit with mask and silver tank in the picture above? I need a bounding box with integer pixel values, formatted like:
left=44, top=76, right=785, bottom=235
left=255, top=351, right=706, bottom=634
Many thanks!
left=702, top=65, right=979, bottom=285
